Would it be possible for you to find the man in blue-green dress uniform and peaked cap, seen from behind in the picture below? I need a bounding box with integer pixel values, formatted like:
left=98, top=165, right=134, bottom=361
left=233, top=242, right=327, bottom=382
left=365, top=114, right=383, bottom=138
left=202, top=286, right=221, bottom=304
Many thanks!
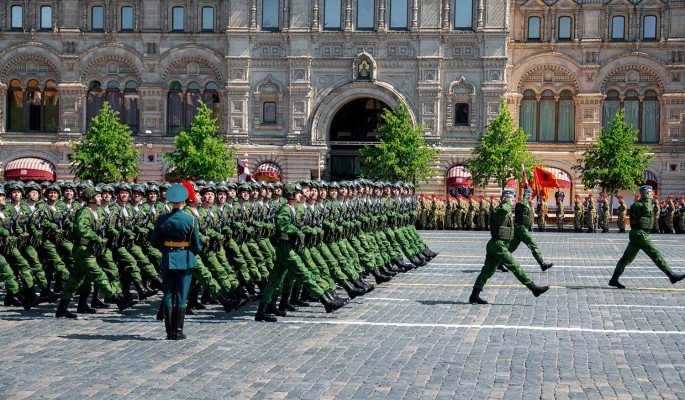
left=150, top=183, right=202, bottom=340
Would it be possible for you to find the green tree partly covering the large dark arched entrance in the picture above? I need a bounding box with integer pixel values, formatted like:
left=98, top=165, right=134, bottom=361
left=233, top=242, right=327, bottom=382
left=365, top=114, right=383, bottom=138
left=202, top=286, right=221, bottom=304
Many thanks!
left=359, top=103, right=439, bottom=183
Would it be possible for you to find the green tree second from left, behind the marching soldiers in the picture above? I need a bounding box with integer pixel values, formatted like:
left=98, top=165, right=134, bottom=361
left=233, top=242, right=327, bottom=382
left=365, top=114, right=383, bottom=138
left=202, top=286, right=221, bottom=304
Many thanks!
left=162, top=102, right=236, bottom=182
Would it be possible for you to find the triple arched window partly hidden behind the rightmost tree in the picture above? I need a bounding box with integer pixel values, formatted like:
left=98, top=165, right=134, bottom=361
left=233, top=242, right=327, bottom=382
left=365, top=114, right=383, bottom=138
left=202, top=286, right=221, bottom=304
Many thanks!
left=602, top=90, right=661, bottom=143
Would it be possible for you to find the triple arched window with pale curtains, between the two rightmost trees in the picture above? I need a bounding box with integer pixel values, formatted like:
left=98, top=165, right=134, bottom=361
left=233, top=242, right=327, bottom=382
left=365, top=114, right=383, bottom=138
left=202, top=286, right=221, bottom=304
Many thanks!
left=520, top=89, right=575, bottom=142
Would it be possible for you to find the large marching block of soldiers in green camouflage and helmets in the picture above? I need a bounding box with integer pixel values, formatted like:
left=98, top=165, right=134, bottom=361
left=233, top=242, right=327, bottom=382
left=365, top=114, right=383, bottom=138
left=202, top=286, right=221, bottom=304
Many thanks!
left=0, top=179, right=437, bottom=321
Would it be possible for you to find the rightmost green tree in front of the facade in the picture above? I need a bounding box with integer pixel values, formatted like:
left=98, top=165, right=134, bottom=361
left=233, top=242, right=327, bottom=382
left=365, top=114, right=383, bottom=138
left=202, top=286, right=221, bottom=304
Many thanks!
left=573, top=109, right=654, bottom=206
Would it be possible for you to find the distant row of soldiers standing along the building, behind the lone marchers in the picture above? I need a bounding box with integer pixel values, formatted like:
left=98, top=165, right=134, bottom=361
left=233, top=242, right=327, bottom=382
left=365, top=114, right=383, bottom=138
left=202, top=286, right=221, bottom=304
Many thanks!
left=416, top=191, right=685, bottom=234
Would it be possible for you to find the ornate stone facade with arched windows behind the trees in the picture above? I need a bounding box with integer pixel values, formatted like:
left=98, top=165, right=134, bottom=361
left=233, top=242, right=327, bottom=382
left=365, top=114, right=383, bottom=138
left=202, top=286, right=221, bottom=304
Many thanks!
left=0, top=0, right=685, bottom=199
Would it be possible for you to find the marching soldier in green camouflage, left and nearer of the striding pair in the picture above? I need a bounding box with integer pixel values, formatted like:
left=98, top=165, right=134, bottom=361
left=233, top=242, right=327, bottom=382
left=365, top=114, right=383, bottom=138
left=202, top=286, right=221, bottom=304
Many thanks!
left=469, top=189, right=549, bottom=304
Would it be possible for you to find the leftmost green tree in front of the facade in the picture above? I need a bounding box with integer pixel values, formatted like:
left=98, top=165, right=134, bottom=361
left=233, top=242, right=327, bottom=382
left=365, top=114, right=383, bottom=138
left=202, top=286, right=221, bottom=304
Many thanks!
left=69, top=102, right=140, bottom=182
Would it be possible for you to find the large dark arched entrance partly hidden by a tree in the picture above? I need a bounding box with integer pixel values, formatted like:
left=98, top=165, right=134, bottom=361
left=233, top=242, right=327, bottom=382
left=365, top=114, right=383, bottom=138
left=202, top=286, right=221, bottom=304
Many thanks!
left=328, top=97, right=390, bottom=181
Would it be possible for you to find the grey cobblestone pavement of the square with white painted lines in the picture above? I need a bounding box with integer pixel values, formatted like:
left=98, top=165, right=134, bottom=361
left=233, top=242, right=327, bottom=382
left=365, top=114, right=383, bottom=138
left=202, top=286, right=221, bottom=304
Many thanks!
left=0, top=231, right=685, bottom=399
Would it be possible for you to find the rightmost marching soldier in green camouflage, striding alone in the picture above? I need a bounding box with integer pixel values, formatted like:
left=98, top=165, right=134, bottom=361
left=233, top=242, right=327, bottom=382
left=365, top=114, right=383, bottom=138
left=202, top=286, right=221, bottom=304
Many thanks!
left=609, top=185, right=685, bottom=289
